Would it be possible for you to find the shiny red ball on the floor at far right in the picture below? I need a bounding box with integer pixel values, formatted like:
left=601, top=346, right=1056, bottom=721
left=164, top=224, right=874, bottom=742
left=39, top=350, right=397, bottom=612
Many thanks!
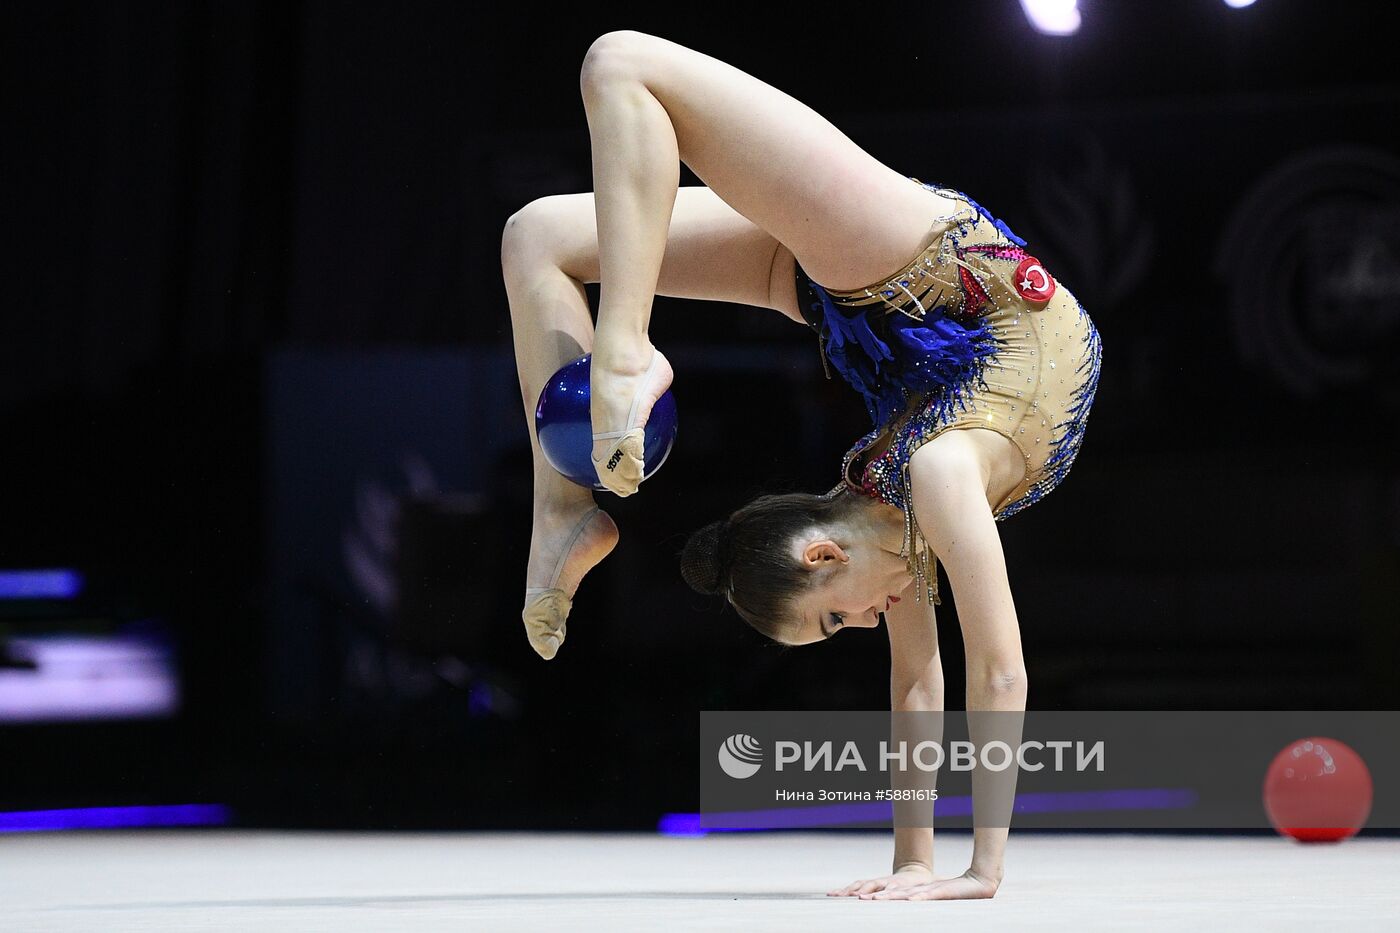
left=1264, top=735, right=1372, bottom=842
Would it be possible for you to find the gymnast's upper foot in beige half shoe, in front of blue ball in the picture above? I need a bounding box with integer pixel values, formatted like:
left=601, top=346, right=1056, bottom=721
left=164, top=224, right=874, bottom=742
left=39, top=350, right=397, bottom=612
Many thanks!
left=588, top=340, right=673, bottom=496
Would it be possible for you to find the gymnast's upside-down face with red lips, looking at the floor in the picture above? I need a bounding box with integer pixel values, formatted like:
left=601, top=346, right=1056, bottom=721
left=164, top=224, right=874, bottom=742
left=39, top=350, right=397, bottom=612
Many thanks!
left=788, top=526, right=911, bottom=644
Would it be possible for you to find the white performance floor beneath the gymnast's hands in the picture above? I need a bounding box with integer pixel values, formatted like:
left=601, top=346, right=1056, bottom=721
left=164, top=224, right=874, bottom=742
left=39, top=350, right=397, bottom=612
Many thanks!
left=0, top=831, right=1400, bottom=933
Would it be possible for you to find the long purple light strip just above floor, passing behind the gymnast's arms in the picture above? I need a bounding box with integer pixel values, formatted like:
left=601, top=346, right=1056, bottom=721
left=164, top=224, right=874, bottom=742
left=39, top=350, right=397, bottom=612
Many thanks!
left=657, top=787, right=1198, bottom=836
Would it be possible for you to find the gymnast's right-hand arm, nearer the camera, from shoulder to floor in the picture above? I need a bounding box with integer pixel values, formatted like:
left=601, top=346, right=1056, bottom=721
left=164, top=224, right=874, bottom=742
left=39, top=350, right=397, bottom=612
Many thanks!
left=909, top=444, right=1026, bottom=897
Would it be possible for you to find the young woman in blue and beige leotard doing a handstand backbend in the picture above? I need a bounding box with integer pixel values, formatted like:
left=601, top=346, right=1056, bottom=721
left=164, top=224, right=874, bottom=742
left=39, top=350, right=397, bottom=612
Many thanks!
left=501, top=32, right=1102, bottom=899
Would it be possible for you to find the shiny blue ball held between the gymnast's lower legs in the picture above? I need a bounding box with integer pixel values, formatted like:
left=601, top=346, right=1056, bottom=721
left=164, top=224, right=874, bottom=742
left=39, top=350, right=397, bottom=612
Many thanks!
left=535, top=353, right=676, bottom=490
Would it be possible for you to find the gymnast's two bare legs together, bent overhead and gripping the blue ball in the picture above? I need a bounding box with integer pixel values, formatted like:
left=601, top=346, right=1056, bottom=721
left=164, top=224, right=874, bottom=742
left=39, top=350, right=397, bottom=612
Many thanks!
left=501, top=32, right=946, bottom=658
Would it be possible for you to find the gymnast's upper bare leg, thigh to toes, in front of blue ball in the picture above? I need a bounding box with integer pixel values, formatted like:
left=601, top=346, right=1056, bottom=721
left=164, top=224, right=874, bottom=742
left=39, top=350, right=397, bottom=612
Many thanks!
left=581, top=32, right=941, bottom=496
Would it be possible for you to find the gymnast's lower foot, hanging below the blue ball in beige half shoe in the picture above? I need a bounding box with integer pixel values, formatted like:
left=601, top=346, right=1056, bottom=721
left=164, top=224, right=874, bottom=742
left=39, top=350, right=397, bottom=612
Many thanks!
left=521, top=499, right=617, bottom=661
